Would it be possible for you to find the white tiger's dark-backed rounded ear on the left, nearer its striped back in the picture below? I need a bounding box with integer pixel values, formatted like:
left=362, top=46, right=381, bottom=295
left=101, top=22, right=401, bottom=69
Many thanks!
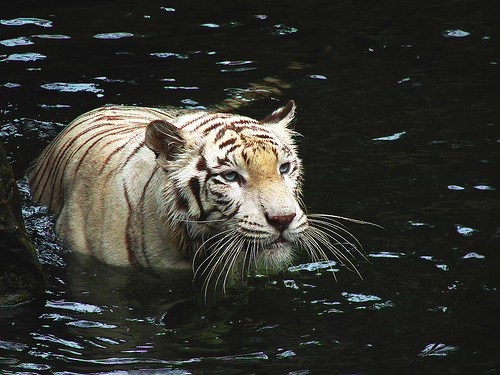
left=145, top=120, right=186, bottom=167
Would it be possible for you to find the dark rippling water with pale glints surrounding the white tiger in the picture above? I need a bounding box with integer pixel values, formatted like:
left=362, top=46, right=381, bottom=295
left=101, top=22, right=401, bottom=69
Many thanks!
left=0, top=0, right=500, bottom=374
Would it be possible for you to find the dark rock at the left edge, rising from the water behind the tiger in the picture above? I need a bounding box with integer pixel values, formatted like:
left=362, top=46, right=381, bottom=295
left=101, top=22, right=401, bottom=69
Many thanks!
left=0, top=143, right=47, bottom=306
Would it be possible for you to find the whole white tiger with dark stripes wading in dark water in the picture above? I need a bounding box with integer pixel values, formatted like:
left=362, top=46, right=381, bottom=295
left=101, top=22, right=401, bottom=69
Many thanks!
left=28, top=101, right=364, bottom=292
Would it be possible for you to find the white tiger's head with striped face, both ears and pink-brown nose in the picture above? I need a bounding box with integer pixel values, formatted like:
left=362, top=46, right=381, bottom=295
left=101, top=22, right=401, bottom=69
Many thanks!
left=146, top=101, right=360, bottom=290
